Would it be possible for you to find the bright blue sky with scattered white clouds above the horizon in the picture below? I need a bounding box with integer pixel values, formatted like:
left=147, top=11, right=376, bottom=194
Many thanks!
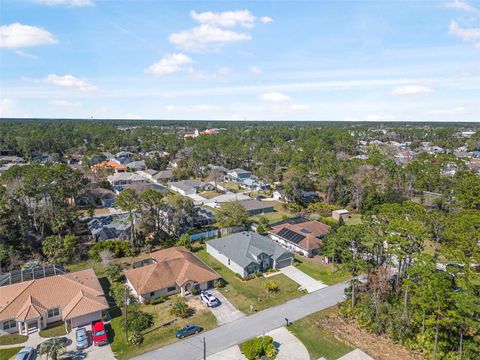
left=0, top=0, right=480, bottom=121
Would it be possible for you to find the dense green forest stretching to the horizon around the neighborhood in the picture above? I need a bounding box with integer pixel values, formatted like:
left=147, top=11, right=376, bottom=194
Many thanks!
left=0, top=120, right=480, bottom=359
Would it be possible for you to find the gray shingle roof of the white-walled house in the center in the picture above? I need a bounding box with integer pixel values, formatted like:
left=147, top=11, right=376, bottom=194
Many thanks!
left=207, top=231, right=290, bottom=267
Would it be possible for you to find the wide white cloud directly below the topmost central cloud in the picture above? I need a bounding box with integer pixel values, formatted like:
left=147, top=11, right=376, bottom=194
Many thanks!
left=168, top=24, right=252, bottom=52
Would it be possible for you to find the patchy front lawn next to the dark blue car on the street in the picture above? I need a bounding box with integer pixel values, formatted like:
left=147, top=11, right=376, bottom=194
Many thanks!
left=107, top=297, right=217, bottom=360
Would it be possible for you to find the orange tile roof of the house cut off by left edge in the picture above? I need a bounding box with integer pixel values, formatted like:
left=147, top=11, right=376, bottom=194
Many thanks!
left=0, top=269, right=108, bottom=321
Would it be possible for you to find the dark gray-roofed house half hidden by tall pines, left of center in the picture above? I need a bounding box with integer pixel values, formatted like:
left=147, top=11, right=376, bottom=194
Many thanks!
left=87, top=214, right=131, bottom=241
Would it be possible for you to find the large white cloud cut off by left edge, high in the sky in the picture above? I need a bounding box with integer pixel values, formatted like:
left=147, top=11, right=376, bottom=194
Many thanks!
left=0, top=23, right=58, bottom=49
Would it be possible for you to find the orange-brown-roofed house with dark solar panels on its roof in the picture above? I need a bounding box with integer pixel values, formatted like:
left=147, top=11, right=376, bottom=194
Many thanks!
left=270, top=221, right=330, bottom=256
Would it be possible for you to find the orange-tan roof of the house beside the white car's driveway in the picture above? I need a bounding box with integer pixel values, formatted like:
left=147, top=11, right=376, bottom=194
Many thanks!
left=125, top=247, right=221, bottom=295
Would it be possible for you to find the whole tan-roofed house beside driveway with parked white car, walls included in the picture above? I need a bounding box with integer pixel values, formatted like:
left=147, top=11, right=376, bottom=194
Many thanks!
left=125, top=246, right=221, bottom=303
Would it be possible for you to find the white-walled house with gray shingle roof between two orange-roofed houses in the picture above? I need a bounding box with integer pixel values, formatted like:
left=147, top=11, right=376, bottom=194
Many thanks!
left=206, top=232, right=294, bottom=277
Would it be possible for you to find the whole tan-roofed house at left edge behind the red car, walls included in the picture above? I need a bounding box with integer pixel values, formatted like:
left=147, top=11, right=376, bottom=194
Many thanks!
left=0, top=269, right=108, bottom=335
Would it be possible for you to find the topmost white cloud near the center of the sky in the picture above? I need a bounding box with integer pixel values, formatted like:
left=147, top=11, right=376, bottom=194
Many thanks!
left=190, top=10, right=255, bottom=28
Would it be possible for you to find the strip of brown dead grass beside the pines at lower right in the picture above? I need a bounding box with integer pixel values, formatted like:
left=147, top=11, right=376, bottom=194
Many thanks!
left=316, top=308, right=425, bottom=360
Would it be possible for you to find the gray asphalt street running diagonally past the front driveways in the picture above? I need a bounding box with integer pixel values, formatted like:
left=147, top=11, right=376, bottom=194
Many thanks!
left=134, top=283, right=346, bottom=360
